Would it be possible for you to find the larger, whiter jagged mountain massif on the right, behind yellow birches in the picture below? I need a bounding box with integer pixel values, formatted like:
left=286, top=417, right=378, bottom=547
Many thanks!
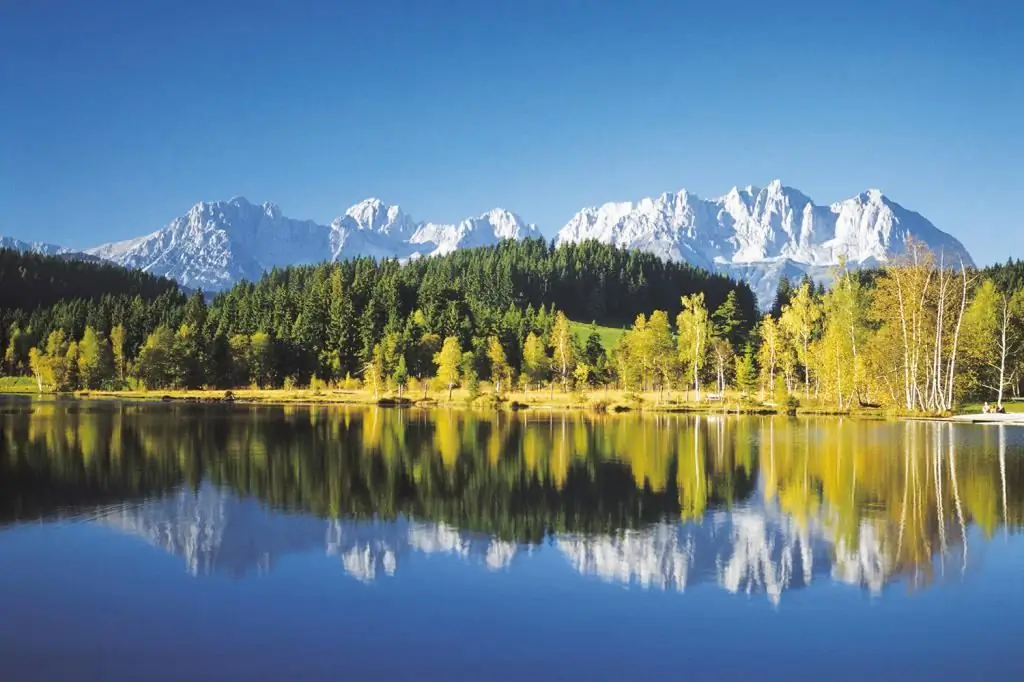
left=556, top=180, right=973, bottom=305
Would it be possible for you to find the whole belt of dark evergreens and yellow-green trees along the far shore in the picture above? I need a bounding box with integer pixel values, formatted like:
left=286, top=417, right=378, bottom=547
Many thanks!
left=0, top=241, right=1024, bottom=413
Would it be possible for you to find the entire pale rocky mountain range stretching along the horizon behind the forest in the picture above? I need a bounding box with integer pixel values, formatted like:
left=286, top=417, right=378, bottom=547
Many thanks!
left=0, top=180, right=974, bottom=306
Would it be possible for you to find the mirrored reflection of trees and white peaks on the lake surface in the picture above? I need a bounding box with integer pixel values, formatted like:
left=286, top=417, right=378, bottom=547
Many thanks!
left=0, top=401, right=1024, bottom=599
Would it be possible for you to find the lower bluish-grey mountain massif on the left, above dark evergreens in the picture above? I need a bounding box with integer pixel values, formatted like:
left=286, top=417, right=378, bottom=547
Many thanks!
left=86, top=197, right=540, bottom=291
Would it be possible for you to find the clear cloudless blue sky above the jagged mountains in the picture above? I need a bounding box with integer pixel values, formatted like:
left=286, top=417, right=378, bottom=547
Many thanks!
left=0, top=0, right=1024, bottom=262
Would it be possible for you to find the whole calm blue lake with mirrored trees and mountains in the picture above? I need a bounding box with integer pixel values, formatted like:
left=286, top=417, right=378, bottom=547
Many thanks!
left=0, top=398, right=1024, bottom=682
